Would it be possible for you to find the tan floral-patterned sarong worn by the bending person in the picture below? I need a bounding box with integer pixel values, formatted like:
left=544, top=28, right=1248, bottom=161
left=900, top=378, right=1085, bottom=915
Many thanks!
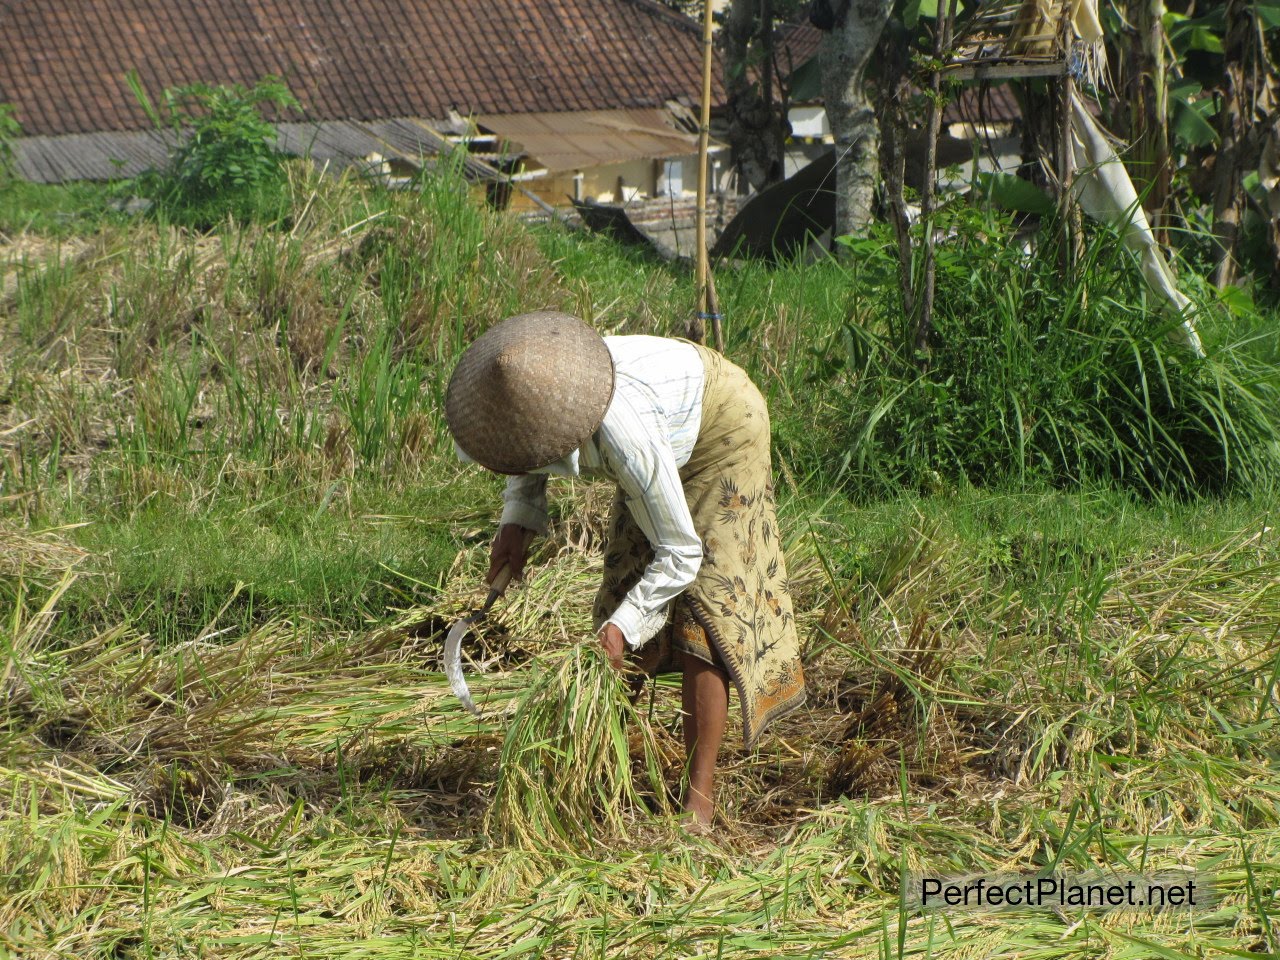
left=594, top=344, right=805, bottom=750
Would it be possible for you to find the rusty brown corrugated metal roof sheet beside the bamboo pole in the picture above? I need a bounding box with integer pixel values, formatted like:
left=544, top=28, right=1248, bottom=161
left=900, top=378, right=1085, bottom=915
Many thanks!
left=476, top=109, right=721, bottom=173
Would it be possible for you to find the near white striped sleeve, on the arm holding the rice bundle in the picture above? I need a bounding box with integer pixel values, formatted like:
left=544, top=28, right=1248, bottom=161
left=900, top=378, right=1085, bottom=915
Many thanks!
left=598, top=402, right=703, bottom=649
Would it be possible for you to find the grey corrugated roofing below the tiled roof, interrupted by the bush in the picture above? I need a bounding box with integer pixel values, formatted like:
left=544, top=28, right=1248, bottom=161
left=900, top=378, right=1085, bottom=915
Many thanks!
left=15, top=118, right=503, bottom=183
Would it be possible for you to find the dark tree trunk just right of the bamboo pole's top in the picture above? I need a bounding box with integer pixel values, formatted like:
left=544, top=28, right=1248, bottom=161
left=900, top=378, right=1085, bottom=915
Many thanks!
left=721, top=0, right=791, bottom=189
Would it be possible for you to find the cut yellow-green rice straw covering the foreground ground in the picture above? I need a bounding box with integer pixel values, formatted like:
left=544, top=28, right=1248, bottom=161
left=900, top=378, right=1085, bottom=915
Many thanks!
left=0, top=496, right=1280, bottom=960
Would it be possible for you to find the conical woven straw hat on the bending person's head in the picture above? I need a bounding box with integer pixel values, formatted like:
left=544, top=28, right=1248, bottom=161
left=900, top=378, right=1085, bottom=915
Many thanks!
left=444, top=310, right=613, bottom=474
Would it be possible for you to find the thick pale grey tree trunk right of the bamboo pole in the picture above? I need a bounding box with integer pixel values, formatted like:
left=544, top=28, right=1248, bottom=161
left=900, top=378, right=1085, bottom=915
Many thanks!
left=819, top=0, right=893, bottom=237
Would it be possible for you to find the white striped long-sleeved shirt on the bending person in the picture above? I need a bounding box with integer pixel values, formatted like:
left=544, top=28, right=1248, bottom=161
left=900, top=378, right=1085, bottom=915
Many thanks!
left=502, top=337, right=705, bottom=648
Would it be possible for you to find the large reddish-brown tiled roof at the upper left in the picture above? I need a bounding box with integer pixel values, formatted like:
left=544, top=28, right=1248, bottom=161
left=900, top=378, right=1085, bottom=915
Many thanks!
left=0, top=0, right=721, bottom=136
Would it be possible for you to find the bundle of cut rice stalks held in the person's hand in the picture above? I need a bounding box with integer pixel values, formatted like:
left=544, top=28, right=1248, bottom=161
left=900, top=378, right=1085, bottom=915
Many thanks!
left=485, top=644, right=667, bottom=850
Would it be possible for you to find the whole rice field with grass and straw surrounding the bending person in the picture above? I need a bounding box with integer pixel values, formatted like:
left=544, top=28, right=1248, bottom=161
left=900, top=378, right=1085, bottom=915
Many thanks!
left=0, top=168, right=1280, bottom=960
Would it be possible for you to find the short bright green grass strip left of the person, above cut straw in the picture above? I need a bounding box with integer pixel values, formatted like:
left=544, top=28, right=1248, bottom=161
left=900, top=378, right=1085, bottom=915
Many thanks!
left=51, top=471, right=495, bottom=644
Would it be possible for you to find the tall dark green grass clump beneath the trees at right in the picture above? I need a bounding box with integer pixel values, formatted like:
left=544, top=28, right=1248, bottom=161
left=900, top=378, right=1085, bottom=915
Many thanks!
left=818, top=209, right=1280, bottom=495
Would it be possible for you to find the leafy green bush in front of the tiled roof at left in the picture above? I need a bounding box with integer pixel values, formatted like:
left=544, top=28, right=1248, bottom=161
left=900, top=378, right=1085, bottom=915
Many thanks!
left=136, top=77, right=298, bottom=227
